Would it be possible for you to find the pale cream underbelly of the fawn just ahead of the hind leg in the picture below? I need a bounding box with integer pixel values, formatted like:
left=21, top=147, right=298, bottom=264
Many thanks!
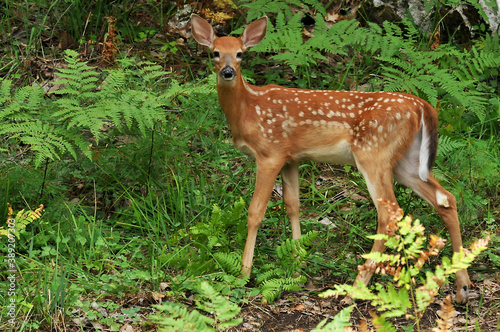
left=294, top=140, right=356, bottom=165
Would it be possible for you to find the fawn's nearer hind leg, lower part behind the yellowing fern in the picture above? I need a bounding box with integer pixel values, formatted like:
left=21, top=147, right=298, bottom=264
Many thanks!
left=354, top=159, right=399, bottom=285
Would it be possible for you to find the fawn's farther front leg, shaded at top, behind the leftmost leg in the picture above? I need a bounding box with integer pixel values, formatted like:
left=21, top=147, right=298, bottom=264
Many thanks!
left=281, top=160, right=300, bottom=239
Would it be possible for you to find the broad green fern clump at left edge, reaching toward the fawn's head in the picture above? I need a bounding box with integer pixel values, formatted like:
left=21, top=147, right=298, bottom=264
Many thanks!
left=0, top=50, right=178, bottom=166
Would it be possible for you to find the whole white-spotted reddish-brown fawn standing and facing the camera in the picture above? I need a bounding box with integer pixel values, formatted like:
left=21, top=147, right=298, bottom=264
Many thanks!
left=191, top=15, right=470, bottom=303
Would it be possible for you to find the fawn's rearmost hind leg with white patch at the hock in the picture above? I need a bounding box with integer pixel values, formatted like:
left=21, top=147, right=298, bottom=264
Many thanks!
left=394, top=166, right=471, bottom=303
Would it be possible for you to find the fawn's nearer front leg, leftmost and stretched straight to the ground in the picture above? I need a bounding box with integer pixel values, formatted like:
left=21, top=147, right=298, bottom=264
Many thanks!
left=241, top=159, right=283, bottom=277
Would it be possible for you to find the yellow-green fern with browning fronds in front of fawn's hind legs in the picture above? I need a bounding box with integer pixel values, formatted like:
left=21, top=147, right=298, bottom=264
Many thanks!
left=320, top=211, right=489, bottom=331
